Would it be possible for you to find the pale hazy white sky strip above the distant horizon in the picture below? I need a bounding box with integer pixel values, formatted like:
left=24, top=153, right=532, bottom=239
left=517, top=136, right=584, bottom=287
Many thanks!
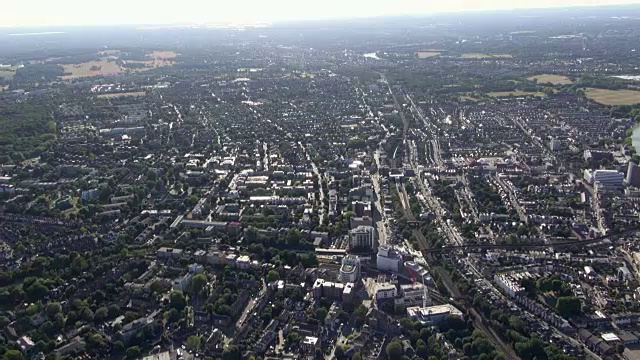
left=0, top=0, right=640, bottom=27
